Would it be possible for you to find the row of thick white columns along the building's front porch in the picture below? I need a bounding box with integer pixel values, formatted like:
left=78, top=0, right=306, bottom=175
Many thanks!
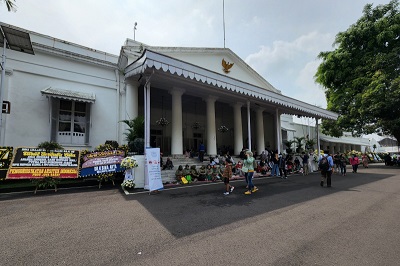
left=125, top=82, right=281, bottom=155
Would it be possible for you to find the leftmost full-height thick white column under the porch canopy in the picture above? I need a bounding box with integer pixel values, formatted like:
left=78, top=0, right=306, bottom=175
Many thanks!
left=169, top=88, right=185, bottom=155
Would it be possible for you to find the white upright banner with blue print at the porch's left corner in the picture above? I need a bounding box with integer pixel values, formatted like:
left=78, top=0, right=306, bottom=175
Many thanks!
left=144, top=148, right=164, bottom=191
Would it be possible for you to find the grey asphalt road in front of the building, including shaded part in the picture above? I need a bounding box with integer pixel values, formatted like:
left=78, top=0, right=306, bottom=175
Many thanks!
left=0, top=164, right=400, bottom=266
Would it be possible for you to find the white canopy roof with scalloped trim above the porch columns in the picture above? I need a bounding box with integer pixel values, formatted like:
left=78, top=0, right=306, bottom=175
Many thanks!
left=125, top=49, right=338, bottom=119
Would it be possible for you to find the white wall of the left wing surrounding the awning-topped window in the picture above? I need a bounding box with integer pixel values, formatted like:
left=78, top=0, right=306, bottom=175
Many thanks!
left=0, top=39, right=119, bottom=149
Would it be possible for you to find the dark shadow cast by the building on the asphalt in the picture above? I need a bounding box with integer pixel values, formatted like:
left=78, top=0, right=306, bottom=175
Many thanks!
left=122, top=165, right=393, bottom=237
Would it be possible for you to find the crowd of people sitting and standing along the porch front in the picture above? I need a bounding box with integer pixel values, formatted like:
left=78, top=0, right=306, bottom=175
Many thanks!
left=162, top=144, right=382, bottom=195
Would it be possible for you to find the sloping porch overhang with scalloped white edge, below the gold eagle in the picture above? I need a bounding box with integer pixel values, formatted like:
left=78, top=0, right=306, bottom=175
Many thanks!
left=125, top=50, right=338, bottom=120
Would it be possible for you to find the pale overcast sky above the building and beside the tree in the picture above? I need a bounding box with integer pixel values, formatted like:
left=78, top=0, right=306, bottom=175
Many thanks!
left=0, top=0, right=390, bottom=113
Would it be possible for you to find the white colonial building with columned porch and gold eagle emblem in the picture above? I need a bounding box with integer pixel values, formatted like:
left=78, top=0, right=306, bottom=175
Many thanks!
left=0, top=23, right=337, bottom=155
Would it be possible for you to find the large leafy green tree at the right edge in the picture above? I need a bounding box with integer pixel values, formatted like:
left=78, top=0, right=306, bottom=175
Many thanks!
left=315, top=0, right=400, bottom=140
